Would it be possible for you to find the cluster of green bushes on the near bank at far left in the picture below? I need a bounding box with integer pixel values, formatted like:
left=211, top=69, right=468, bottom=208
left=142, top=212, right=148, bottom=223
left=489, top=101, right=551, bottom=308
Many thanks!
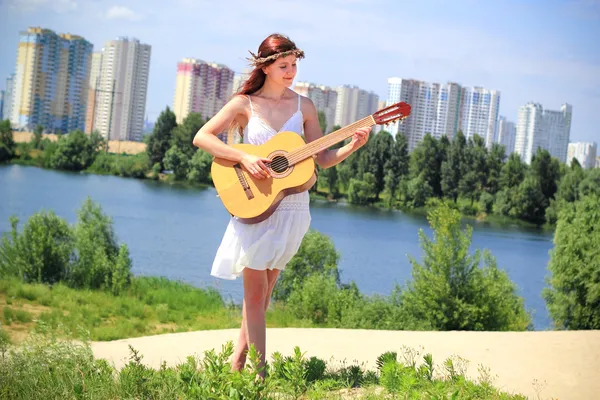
left=0, top=198, right=131, bottom=294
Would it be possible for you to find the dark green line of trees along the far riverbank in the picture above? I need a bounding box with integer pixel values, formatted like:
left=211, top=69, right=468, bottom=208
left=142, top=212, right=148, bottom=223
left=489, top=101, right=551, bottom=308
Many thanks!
left=0, top=107, right=600, bottom=228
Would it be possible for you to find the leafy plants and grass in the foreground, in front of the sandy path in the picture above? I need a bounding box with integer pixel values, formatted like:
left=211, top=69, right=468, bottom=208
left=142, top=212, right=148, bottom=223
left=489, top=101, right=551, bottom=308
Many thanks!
left=0, top=328, right=525, bottom=400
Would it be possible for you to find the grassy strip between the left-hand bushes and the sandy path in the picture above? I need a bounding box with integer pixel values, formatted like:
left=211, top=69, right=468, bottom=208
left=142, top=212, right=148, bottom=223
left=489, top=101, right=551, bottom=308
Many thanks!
left=0, top=277, right=312, bottom=342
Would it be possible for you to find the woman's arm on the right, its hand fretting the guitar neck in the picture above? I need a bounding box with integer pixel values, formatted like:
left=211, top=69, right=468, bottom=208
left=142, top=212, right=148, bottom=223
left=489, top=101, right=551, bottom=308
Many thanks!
left=302, top=97, right=371, bottom=168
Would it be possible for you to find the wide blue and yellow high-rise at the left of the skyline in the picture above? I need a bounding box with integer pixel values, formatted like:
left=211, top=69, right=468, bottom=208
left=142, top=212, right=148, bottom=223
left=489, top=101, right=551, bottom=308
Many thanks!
left=10, top=28, right=93, bottom=133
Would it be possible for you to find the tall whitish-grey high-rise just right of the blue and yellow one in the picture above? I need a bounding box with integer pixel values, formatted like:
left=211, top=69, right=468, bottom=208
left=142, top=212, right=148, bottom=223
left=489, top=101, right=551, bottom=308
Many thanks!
left=88, top=37, right=152, bottom=141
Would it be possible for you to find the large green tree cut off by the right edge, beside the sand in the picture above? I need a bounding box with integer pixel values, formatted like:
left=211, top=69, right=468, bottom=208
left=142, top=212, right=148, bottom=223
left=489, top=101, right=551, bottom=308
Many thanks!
left=543, top=194, right=600, bottom=329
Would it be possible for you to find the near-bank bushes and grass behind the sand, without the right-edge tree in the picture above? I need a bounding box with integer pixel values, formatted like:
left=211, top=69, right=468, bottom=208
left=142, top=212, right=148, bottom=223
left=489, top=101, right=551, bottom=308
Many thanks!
left=0, top=198, right=531, bottom=346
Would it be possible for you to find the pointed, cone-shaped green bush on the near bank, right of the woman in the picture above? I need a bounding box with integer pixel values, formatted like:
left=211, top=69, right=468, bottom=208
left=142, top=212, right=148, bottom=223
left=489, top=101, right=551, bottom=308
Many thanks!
left=401, top=203, right=531, bottom=331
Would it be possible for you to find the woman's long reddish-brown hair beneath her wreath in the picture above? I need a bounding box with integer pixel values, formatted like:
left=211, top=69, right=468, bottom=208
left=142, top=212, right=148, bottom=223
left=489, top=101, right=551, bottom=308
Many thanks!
left=228, top=33, right=304, bottom=142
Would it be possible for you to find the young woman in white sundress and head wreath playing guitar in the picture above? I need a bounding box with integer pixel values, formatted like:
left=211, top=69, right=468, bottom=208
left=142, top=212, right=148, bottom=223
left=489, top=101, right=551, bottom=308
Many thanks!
left=193, top=34, right=371, bottom=377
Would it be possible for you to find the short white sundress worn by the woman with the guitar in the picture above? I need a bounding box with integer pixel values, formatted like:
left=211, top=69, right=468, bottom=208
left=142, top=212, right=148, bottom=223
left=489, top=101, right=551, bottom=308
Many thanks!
left=211, top=95, right=311, bottom=280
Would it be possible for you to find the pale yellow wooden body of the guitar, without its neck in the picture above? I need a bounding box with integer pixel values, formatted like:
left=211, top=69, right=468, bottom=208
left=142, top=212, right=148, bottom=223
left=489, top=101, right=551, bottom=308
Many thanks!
left=211, top=132, right=317, bottom=224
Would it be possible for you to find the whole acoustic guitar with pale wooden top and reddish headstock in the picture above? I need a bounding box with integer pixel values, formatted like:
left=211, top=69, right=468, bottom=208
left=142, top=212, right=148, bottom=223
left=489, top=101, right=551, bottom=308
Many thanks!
left=211, top=102, right=411, bottom=224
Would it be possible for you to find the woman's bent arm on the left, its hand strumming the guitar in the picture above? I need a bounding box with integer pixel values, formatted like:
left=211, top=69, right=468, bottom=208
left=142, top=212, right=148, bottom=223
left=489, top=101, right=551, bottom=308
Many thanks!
left=192, top=96, right=270, bottom=179
